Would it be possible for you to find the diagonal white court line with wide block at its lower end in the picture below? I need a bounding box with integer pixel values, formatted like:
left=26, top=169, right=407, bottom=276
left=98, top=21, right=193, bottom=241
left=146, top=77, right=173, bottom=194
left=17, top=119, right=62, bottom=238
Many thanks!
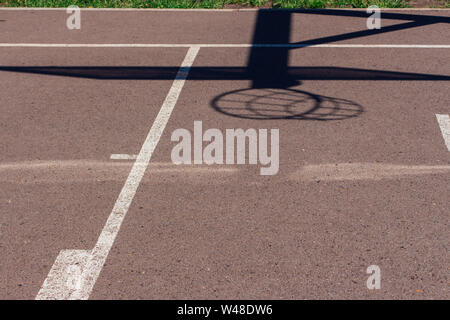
left=36, top=47, right=200, bottom=300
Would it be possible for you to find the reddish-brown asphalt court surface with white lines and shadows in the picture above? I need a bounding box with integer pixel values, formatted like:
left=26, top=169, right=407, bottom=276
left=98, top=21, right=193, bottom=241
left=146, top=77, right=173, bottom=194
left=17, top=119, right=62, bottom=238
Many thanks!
left=0, top=9, right=450, bottom=299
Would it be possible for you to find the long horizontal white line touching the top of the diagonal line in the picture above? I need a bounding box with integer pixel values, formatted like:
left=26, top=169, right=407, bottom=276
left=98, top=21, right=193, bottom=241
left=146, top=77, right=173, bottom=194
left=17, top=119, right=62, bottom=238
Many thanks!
left=0, top=43, right=450, bottom=49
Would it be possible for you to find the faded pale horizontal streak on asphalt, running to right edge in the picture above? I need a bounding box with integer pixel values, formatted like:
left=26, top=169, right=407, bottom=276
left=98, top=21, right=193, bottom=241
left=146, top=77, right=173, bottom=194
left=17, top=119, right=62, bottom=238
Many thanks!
left=293, top=163, right=450, bottom=182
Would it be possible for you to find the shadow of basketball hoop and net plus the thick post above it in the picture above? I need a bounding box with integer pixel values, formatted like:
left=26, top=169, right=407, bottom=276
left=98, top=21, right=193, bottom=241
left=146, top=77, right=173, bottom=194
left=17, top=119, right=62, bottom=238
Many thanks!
left=211, top=10, right=363, bottom=121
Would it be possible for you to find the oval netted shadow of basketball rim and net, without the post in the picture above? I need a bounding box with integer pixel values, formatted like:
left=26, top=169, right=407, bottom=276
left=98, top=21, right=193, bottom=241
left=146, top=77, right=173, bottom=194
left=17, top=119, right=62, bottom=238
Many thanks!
left=211, top=88, right=363, bottom=121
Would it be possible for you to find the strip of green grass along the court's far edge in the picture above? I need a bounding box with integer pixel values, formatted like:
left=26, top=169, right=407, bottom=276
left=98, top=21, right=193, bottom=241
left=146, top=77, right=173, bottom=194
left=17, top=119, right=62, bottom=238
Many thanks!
left=0, top=0, right=418, bottom=9
